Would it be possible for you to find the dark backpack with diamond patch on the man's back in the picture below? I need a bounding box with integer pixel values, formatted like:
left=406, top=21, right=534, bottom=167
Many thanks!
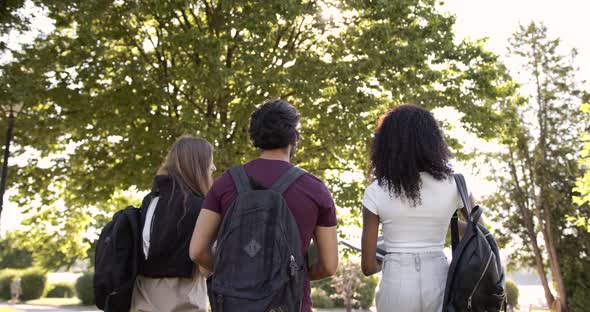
left=207, top=166, right=306, bottom=312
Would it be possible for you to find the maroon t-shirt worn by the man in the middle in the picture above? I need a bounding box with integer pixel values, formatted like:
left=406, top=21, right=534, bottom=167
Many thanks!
left=203, top=158, right=337, bottom=312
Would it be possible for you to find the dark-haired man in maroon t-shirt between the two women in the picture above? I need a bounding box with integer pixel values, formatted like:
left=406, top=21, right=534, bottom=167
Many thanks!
left=190, top=100, right=338, bottom=312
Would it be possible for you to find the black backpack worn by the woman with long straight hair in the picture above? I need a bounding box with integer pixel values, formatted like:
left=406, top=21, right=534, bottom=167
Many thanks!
left=93, top=206, right=140, bottom=312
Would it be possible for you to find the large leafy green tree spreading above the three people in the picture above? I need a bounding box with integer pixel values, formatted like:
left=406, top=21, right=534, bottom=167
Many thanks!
left=5, top=0, right=514, bottom=266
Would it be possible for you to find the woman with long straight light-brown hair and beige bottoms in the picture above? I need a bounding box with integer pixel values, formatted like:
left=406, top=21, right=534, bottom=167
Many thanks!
left=131, top=136, right=215, bottom=312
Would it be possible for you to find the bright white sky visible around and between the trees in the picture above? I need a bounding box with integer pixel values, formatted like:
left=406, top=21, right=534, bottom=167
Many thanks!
left=0, top=0, right=590, bottom=232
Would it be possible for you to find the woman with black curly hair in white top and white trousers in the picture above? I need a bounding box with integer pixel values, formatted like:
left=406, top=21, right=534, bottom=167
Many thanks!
left=362, top=105, right=474, bottom=312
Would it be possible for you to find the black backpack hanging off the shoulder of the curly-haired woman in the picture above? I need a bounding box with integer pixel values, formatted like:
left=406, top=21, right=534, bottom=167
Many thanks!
left=443, top=174, right=506, bottom=312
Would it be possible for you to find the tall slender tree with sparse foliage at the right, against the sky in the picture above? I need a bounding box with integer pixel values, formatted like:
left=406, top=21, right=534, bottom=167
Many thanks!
left=488, top=23, right=590, bottom=311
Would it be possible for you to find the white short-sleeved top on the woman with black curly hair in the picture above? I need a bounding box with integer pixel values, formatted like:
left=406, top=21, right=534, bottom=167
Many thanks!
left=363, top=172, right=470, bottom=252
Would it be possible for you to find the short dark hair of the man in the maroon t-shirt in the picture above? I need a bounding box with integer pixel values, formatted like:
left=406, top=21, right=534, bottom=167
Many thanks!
left=248, top=100, right=299, bottom=150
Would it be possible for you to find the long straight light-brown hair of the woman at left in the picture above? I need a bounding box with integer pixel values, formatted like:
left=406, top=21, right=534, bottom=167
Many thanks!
left=158, top=135, right=213, bottom=198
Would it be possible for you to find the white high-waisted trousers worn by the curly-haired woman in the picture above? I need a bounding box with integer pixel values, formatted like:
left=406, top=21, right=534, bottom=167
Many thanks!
left=376, top=251, right=449, bottom=312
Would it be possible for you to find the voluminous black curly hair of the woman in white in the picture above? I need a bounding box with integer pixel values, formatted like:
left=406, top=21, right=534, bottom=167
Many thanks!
left=370, top=105, right=453, bottom=205
